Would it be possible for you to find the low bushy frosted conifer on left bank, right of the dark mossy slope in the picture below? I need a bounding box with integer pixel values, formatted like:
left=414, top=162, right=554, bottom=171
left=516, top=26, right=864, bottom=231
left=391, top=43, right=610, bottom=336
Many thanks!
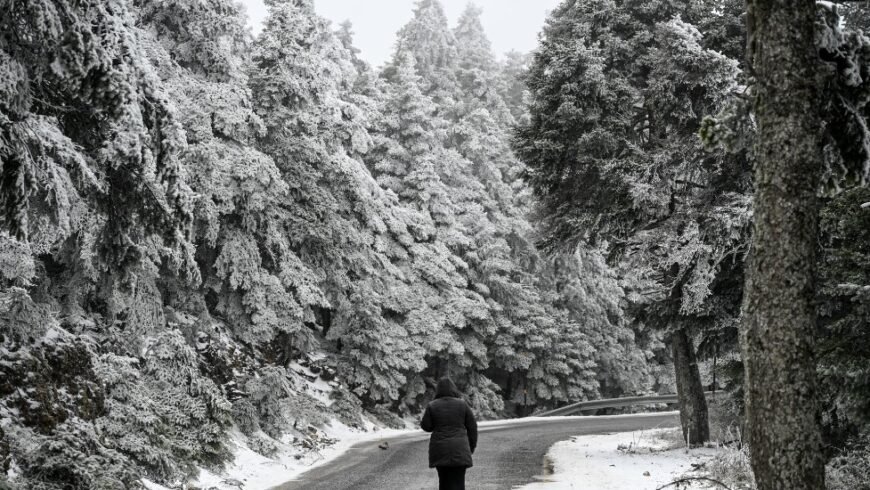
left=94, top=329, right=231, bottom=481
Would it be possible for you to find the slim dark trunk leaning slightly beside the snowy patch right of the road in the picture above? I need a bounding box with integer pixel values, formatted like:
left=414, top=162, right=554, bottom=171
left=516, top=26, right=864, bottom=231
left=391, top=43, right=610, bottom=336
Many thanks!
left=671, top=328, right=710, bottom=446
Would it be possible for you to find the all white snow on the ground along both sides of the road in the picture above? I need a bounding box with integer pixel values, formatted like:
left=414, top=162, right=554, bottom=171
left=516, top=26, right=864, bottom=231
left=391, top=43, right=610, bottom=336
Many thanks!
left=143, top=412, right=717, bottom=490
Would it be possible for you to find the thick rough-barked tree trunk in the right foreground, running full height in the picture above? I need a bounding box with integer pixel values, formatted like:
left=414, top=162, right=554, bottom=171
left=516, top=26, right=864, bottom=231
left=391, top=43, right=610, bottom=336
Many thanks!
left=741, top=0, right=825, bottom=490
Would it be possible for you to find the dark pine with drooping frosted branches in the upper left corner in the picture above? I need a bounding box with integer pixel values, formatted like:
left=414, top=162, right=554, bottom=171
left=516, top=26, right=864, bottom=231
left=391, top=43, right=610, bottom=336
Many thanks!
left=0, top=2, right=191, bottom=268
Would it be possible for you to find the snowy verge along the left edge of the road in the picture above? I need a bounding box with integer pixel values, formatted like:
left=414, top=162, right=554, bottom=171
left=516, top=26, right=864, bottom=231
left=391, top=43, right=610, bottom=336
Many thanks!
left=142, top=422, right=411, bottom=490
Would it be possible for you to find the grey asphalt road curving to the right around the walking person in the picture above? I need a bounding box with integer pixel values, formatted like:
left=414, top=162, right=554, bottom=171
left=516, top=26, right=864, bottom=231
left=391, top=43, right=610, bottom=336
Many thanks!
left=273, top=412, right=679, bottom=490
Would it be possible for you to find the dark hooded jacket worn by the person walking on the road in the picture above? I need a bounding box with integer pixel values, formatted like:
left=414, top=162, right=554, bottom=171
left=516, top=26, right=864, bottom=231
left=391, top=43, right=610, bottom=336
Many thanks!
left=420, top=378, right=477, bottom=468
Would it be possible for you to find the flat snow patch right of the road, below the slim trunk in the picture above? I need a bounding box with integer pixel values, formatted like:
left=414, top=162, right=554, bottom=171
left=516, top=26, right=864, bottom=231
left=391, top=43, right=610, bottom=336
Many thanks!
left=517, top=429, right=719, bottom=490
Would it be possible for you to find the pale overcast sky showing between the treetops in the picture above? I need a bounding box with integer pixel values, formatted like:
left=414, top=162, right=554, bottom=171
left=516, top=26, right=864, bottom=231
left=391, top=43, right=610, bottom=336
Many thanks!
left=240, top=0, right=561, bottom=66
